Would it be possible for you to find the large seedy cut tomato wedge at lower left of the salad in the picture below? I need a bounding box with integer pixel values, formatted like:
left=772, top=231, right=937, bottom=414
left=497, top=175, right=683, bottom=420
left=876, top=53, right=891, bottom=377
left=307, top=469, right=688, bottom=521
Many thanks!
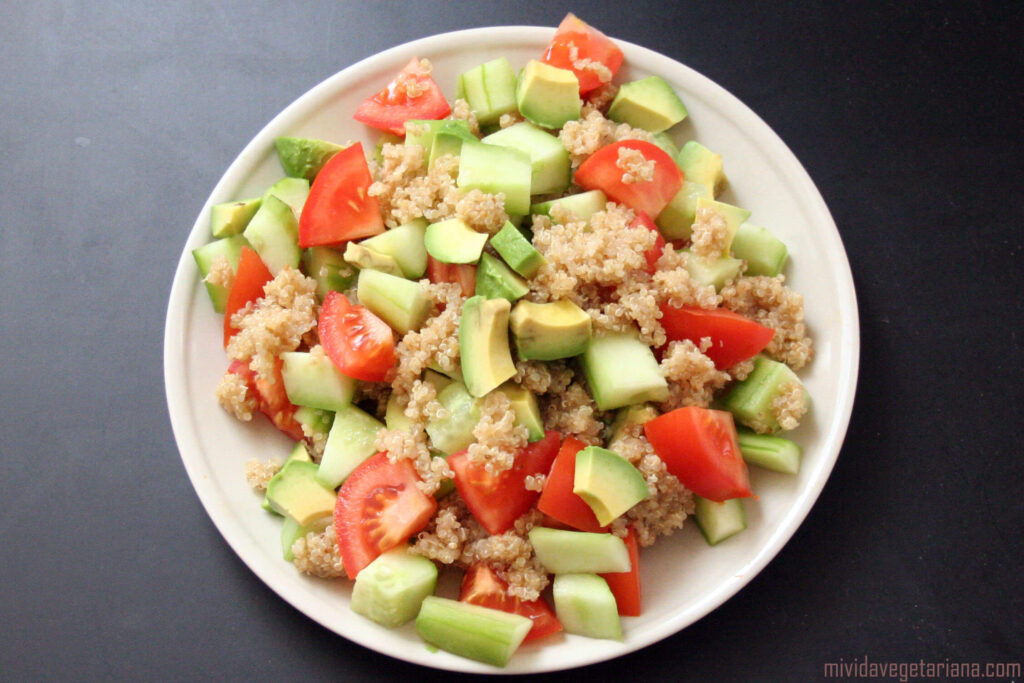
left=334, top=453, right=437, bottom=579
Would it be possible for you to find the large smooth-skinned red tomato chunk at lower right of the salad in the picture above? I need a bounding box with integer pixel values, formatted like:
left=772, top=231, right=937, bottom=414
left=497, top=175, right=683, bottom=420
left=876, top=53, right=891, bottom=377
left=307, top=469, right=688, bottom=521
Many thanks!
left=643, top=405, right=754, bottom=503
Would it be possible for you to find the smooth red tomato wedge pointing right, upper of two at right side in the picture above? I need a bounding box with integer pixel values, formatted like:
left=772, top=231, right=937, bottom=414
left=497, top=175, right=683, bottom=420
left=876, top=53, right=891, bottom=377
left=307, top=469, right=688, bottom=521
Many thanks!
left=662, top=303, right=775, bottom=370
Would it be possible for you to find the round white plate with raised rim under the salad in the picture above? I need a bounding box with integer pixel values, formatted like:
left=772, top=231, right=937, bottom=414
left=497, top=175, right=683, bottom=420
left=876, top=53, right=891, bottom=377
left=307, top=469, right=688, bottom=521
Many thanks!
left=164, top=27, right=859, bottom=673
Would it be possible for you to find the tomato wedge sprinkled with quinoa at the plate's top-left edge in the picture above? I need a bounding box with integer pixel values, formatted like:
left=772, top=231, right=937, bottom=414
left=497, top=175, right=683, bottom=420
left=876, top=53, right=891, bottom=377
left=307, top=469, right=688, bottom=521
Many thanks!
left=352, top=57, right=452, bottom=136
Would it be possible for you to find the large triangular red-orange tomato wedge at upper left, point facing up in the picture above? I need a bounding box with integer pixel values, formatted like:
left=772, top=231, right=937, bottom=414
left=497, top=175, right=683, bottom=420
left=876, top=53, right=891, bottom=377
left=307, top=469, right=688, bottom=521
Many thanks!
left=299, top=142, right=384, bottom=249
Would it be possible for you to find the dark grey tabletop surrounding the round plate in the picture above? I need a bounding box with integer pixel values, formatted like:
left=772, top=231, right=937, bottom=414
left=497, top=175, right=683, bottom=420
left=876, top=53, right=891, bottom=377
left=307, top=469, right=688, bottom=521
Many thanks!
left=0, top=1, right=1024, bottom=681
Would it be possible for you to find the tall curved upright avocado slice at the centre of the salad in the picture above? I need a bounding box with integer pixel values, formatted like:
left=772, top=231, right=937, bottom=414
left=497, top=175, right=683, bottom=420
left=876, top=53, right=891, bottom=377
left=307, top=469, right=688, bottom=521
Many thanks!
left=459, top=295, right=515, bottom=397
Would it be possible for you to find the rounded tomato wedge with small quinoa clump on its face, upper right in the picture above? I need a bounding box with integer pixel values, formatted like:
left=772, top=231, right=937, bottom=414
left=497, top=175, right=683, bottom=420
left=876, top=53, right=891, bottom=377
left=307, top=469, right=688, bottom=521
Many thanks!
left=575, top=140, right=683, bottom=216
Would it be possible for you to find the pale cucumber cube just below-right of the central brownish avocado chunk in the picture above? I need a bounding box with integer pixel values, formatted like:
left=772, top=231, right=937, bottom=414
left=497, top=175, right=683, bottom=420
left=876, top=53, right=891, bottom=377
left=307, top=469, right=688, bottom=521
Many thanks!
left=582, top=332, right=669, bottom=411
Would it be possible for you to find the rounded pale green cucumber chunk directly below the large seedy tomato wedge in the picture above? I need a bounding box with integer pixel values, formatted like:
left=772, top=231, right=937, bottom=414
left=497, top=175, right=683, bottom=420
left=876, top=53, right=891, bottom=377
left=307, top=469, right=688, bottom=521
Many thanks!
left=349, top=545, right=437, bottom=629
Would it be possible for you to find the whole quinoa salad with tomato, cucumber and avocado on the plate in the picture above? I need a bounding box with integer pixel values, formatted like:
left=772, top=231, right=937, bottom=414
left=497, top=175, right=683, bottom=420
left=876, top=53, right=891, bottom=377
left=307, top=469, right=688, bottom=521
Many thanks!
left=196, top=14, right=814, bottom=666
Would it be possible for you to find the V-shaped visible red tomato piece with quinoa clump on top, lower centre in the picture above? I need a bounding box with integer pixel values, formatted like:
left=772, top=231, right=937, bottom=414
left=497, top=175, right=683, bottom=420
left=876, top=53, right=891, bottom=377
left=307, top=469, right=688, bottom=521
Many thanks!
left=447, top=431, right=561, bottom=536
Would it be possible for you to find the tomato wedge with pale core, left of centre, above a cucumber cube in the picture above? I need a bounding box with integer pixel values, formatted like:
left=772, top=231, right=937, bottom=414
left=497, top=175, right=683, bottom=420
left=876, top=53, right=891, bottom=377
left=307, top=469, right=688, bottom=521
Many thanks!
left=316, top=291, right=395, bottom=382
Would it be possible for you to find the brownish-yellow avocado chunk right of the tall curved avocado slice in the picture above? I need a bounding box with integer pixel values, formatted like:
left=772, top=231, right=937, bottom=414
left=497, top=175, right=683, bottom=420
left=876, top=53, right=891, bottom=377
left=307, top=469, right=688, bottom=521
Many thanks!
left=509, top=299, right=593, bottom=360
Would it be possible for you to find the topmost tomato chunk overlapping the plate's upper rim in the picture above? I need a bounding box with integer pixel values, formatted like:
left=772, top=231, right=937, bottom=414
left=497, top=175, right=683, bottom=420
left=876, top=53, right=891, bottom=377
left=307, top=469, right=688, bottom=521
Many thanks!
left=541, top=12, right=623, bottom=95
